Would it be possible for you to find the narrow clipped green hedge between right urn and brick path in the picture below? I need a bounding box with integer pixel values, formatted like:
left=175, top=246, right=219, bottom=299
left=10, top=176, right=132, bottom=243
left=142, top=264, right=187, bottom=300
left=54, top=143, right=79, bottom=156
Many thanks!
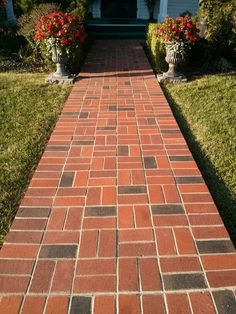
left=146, top=23, right=168, bottom=72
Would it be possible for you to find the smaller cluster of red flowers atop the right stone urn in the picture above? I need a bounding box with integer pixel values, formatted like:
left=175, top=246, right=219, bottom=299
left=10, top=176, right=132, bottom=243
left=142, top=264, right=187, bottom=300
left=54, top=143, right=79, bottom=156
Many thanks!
left=159, top=16, right=199, bottom=45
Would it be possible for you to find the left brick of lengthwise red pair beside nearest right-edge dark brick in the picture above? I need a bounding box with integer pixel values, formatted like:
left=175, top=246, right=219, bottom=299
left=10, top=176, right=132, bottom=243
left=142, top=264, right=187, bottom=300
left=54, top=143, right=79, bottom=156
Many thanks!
left=156, top=228, right=177, bottom=255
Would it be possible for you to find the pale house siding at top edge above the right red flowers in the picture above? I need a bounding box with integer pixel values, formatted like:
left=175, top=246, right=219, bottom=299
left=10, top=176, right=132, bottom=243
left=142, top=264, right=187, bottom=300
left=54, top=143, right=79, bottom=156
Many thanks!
left=167, top=0, right=198, bottom=17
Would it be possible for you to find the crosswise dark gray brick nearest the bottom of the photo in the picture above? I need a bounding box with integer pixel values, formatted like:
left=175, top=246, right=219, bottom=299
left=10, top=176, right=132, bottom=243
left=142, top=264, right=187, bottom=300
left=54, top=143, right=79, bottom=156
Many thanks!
left=163, top=274, right=207, bottom=290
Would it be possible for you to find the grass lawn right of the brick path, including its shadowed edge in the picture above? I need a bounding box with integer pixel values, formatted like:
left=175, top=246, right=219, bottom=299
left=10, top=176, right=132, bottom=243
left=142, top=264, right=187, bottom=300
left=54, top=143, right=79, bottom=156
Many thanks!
left=164, top=74, right=236, bottom=243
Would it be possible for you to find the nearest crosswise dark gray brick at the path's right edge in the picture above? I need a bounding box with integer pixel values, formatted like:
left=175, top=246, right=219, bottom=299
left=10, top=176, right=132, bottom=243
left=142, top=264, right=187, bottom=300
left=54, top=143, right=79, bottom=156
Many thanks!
left=196, top=240, right=235, bottom=254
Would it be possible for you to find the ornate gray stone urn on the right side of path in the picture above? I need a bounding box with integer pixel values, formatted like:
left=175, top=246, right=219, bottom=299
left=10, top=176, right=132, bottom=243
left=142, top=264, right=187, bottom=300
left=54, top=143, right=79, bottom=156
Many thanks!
left=157, top=42, right=186, bottom=83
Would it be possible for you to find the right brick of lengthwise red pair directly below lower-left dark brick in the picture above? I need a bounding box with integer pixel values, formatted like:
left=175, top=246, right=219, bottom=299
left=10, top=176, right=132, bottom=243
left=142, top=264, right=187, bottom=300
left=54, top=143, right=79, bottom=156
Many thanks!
left=51, top=260, right=75, bottom=293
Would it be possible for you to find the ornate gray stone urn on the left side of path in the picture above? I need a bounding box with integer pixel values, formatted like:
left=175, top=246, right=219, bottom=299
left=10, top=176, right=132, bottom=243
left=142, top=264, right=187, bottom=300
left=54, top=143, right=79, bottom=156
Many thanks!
left=46, top=46, right=75, bottom=84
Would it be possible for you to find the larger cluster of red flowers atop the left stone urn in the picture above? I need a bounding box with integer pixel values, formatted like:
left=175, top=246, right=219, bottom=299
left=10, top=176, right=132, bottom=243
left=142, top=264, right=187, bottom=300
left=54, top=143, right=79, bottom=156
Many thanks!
left=34, top=11, right=87, bottom=48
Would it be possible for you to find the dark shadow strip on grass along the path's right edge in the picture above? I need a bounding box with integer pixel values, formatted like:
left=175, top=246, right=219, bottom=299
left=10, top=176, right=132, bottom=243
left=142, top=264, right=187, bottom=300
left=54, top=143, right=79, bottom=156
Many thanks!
left=162, top=85, right=236, bottom=247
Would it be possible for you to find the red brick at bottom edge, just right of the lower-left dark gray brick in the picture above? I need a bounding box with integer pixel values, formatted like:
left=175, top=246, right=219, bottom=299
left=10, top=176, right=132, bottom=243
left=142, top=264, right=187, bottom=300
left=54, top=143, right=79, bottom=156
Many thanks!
left=93, top=296, right=116, bottom=314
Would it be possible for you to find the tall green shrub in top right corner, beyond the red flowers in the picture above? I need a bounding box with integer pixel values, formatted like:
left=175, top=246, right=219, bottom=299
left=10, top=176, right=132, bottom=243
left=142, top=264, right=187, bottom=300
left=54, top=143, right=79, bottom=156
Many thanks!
left=199, top=0, right=236, bottom=59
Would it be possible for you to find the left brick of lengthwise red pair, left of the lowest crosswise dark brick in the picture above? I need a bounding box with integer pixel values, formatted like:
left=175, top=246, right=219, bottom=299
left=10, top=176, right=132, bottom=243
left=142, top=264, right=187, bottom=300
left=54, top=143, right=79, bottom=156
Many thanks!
left=118, top=258, right=139, bottom=291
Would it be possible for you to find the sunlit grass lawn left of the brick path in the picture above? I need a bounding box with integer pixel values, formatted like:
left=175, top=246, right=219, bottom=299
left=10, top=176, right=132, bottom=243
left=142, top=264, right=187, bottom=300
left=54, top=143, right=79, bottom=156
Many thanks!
left=0, top=72, right=71, bottom=243
